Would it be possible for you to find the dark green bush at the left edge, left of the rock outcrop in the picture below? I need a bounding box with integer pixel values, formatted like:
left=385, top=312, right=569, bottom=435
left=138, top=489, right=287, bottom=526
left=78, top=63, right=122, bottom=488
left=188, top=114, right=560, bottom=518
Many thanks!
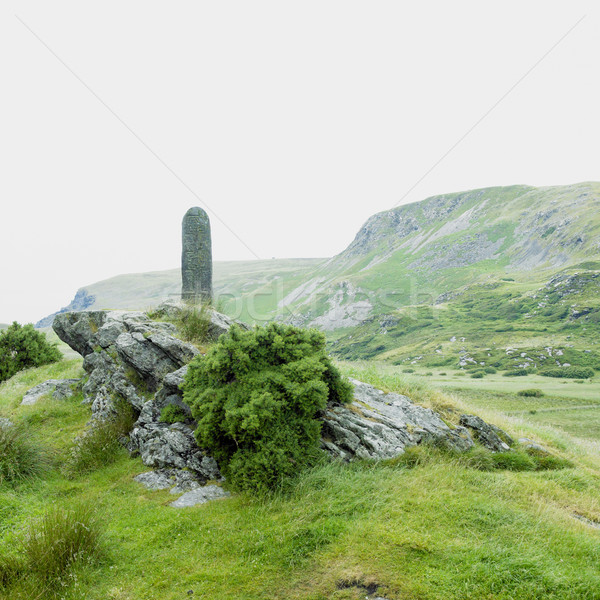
left=0, top=321, right=62, bottom=381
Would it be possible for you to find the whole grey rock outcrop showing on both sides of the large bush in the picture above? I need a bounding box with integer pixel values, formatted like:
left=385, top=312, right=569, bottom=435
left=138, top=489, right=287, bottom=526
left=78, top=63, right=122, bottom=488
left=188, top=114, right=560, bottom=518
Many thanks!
left=54, top=311, right=508, bottom=482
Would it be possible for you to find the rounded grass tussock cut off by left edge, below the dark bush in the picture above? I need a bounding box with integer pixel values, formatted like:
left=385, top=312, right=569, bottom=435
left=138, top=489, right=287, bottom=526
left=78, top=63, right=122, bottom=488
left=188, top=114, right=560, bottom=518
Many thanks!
left=0, top=425, right=50, bottom=483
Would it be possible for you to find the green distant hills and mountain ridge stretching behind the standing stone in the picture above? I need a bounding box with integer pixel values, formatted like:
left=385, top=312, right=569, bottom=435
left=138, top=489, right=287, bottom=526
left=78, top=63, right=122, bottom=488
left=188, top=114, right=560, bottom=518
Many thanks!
left=37, top=182, right=600, bottom=370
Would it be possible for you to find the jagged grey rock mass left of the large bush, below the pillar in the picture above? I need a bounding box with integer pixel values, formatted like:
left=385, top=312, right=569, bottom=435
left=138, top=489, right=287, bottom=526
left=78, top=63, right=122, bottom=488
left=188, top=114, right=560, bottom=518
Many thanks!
left=53, top=302, right=232, bottom=481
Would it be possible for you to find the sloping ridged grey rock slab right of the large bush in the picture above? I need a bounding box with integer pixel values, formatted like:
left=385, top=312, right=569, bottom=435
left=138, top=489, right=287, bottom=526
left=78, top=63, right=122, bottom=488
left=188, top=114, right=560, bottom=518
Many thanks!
left=321, top=380, right=473, bottom=460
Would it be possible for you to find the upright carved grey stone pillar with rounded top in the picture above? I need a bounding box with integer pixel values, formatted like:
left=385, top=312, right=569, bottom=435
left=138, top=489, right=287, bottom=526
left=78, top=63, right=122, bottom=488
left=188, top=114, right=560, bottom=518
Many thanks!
left=181, top=206, right=212, bottom=303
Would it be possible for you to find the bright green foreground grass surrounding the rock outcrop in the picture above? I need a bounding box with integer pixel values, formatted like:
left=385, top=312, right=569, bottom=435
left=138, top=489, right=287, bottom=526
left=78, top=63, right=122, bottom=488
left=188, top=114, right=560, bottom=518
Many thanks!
left=0, top=360, right=600, bottom=600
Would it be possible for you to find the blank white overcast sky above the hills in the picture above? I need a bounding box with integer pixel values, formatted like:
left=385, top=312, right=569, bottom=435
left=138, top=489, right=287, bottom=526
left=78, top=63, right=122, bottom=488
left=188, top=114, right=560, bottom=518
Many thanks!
left=0, top=0, right=600, bottom=322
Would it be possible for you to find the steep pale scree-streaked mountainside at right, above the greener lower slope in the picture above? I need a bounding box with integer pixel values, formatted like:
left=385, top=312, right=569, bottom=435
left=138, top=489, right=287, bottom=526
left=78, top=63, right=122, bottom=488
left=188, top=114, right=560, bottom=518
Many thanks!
left=286, top=183, right=600, bottom=330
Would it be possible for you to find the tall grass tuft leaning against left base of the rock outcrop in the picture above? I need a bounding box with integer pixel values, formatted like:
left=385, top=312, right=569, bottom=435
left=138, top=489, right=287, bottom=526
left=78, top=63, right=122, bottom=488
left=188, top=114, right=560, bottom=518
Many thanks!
left=63, top=401, right=136, bottom=477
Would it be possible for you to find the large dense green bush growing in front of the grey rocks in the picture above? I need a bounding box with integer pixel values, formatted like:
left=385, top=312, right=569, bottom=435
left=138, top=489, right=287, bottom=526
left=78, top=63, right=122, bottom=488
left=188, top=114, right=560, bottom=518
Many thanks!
left=184, top=323, right=352, bottom=493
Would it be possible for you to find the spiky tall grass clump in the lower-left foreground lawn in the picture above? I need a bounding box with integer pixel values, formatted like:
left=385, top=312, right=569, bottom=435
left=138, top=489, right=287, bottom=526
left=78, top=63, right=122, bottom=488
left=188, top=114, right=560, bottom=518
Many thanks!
left=22, top=504, right=100, bottom=585
